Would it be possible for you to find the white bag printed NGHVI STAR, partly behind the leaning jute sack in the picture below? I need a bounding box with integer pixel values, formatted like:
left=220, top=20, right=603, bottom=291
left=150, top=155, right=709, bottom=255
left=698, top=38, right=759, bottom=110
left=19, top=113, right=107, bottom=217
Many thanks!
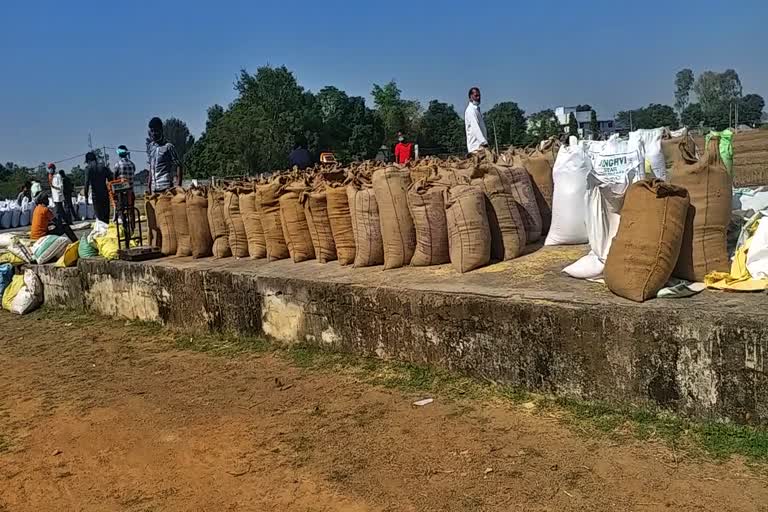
left=563, top=137, right=645, bottom=279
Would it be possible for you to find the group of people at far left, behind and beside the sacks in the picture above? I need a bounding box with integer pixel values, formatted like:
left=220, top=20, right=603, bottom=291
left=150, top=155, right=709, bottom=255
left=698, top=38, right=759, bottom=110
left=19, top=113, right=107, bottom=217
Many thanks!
left=25, top=117, right=183, bottom=242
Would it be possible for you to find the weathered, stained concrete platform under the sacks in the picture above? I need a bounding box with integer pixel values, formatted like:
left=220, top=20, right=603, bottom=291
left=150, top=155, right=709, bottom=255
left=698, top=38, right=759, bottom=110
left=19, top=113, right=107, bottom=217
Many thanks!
left=33, top=246, right=768, bottom=423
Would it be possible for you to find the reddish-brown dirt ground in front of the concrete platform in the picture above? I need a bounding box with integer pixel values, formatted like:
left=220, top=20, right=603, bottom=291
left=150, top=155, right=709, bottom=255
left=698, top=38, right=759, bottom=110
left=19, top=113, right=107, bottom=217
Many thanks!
left=0, top=312, right=768, bottom=512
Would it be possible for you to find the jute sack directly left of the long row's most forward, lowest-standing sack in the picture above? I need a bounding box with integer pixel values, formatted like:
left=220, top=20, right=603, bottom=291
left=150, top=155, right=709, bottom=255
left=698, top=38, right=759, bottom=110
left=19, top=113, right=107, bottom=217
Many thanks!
left=408, top=177, right=451, bottom=267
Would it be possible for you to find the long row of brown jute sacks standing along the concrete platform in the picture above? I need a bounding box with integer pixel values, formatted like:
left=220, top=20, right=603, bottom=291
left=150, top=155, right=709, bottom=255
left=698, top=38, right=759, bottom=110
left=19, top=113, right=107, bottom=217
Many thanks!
left=146, top=155, right=552, bottom=272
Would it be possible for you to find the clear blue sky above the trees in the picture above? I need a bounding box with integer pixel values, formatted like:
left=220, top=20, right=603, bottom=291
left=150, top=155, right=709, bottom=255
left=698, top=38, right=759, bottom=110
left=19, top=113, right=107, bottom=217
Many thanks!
left=0, top=0, right=768, bottom=168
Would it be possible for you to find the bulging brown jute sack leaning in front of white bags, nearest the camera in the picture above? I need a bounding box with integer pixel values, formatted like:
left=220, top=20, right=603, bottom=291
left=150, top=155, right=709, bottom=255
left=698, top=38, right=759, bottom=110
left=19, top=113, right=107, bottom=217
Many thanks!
left=603, top=179, right=690, bottom=302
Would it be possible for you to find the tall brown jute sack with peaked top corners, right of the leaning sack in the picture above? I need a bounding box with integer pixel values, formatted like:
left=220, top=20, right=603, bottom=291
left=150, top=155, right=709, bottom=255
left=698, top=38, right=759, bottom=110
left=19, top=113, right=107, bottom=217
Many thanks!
left=670, top=137, right=733, bottom=281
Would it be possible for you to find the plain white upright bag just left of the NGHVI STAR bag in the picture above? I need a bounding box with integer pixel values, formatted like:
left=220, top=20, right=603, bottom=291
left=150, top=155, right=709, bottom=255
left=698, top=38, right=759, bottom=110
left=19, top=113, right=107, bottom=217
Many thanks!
left=544, top=138, right=591, bottom=245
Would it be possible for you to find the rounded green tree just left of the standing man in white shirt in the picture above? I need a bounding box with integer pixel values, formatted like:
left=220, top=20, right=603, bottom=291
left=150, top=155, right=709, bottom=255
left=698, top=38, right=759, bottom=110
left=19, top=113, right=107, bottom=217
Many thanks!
left=418, top=100, right=466, bottom=153
